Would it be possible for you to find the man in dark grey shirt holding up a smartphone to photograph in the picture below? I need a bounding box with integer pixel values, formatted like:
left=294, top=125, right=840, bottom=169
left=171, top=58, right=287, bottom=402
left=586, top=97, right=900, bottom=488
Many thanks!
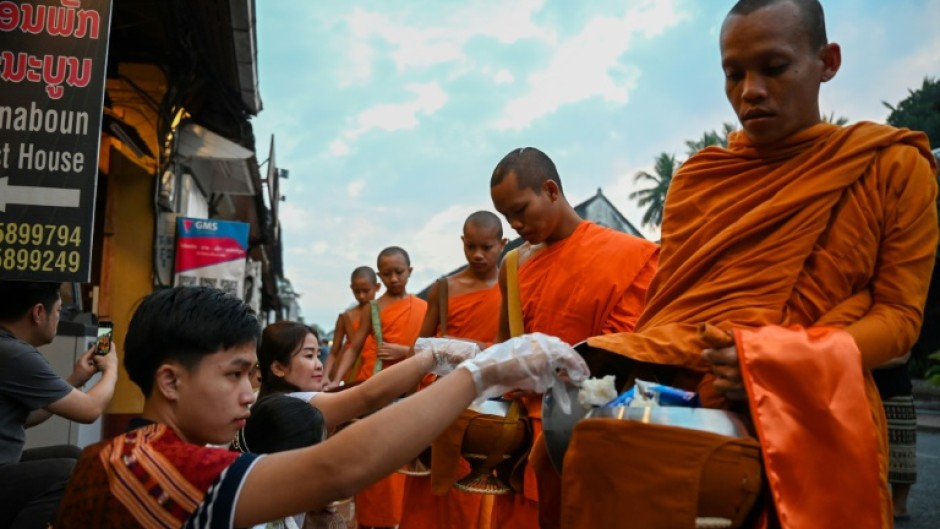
left=0, top=281, right=118, bottom=528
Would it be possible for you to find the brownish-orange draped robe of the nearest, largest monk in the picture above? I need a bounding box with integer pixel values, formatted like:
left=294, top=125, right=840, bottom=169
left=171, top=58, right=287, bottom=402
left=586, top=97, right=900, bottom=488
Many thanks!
left=580, top=123, right=937, bottom=527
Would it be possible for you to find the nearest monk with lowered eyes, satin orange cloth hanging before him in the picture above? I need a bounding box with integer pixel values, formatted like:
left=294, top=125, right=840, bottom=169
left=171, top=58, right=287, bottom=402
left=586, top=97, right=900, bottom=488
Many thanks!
left=562, top=0, right=938, bottom=529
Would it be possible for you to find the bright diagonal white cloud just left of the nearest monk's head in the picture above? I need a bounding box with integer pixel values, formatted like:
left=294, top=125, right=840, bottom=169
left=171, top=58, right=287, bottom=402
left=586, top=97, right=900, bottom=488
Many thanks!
left=494, top=2, right=682, bottom=130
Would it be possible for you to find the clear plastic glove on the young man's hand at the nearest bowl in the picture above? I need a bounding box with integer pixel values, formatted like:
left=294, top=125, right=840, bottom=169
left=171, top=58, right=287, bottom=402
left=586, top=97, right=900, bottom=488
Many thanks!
left=459, top=333, right=590, bottom=409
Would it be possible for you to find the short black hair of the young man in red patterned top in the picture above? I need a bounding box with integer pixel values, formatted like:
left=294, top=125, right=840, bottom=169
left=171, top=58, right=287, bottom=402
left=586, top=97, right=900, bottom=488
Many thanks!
left=124, top=287, right=261, bottom=396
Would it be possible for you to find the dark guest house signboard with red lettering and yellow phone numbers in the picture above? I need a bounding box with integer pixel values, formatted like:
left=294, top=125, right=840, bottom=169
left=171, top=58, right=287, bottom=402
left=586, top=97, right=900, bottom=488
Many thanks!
left=0, top=0, right=111, bottom=282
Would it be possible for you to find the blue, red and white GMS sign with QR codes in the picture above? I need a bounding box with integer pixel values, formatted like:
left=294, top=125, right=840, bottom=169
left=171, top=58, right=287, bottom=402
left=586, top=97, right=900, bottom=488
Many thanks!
left=175, top=217, right=249, bottom=299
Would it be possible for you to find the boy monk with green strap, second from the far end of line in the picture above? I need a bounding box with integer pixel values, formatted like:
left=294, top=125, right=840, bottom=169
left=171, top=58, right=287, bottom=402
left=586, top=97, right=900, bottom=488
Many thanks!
left=330, top=246, right=427, bottom=528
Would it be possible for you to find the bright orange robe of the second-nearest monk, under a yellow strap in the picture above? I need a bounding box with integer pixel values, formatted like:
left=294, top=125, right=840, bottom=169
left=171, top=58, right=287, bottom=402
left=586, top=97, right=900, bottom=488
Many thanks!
left=493, top=221, right=659, bottom=529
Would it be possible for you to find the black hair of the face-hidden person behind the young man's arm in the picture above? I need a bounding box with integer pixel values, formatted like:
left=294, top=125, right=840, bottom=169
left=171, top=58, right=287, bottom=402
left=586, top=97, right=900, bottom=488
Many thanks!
left=233, top=395, right=324, bottom=454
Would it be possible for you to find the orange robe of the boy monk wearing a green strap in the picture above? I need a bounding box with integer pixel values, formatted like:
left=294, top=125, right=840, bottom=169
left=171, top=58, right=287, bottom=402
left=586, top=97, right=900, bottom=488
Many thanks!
left=356, top=295, right=428, bottom=527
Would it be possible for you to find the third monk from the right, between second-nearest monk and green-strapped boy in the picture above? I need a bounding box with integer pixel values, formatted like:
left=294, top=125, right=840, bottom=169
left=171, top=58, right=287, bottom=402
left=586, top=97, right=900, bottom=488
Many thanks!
left=399, top=211, right=506, bottom=529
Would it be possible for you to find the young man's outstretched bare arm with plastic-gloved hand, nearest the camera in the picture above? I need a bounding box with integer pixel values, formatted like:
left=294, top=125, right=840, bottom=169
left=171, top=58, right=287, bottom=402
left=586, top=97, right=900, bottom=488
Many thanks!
left=234, top=335, right=588, bottom=527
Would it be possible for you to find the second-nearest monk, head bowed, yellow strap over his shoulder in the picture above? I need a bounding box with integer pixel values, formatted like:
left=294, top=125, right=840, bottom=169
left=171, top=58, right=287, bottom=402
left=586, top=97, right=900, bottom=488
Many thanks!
left=490, top=147, right=659, bottom=528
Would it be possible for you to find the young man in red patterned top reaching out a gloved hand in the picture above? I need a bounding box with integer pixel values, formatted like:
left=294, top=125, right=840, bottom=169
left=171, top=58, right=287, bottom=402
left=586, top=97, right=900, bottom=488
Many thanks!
left=53, top=287, right=587, bottom=529
